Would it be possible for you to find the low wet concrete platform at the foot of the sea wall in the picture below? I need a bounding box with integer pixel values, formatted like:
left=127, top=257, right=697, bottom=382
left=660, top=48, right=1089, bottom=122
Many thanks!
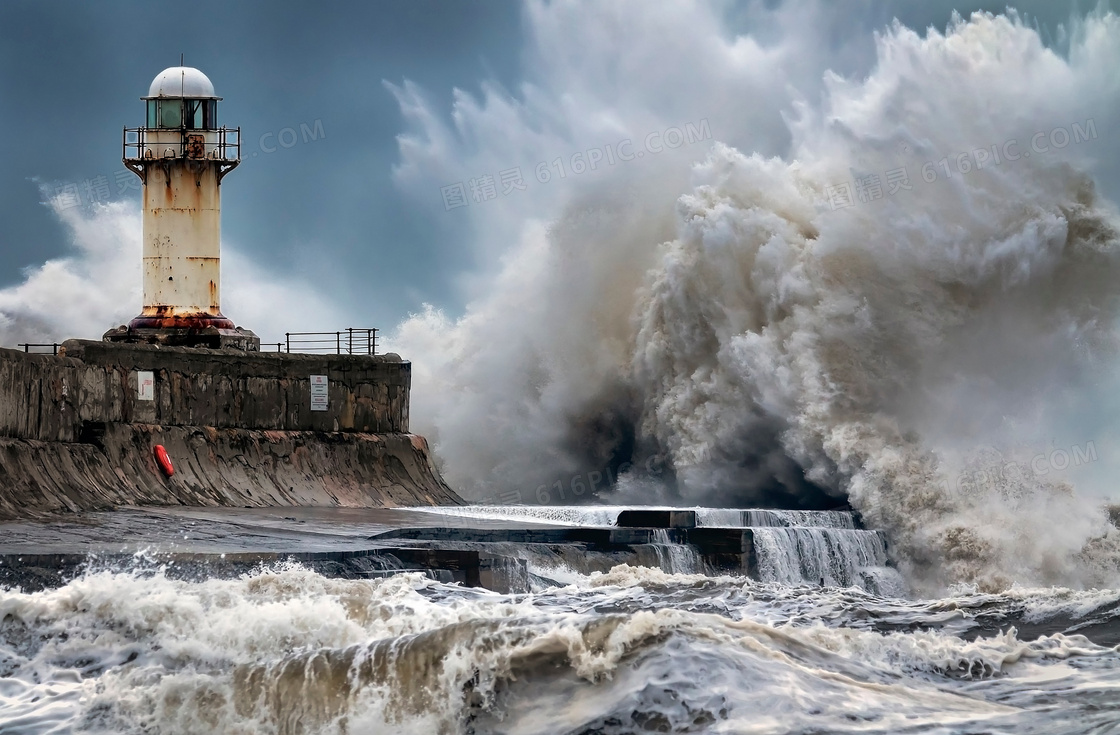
left=0, top=506, right=797, bottom=593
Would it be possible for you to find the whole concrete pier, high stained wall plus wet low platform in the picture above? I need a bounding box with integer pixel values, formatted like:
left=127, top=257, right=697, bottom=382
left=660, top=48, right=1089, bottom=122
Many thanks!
left=0, top=341, right=887, bottom=593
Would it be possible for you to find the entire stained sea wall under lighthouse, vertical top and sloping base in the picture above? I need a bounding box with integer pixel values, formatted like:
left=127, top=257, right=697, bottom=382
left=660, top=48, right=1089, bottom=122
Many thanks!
left=0, top=341, right=461, bottom=519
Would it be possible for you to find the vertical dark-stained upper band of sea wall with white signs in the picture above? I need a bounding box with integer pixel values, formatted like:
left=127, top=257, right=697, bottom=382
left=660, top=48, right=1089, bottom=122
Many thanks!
left=0, top=339, right=412, bottom=441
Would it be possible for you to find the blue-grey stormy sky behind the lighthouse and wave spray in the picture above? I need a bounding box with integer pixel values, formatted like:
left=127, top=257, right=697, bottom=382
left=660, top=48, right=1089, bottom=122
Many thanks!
left=0, top=0, right=1097, bottom=336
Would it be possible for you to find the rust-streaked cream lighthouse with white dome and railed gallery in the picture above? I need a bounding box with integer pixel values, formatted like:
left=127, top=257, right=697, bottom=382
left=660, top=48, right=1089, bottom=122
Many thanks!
left=104, top=66, right=260, bottom=351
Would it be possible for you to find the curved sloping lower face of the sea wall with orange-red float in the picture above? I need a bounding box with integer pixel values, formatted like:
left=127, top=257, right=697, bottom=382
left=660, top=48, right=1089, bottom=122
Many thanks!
left=0, top=424, right=461, bottom=519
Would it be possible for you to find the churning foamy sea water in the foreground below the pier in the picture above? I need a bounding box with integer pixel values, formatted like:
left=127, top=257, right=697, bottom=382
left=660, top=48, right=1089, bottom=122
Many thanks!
left=0, top=509, right=1120, bottom=735
